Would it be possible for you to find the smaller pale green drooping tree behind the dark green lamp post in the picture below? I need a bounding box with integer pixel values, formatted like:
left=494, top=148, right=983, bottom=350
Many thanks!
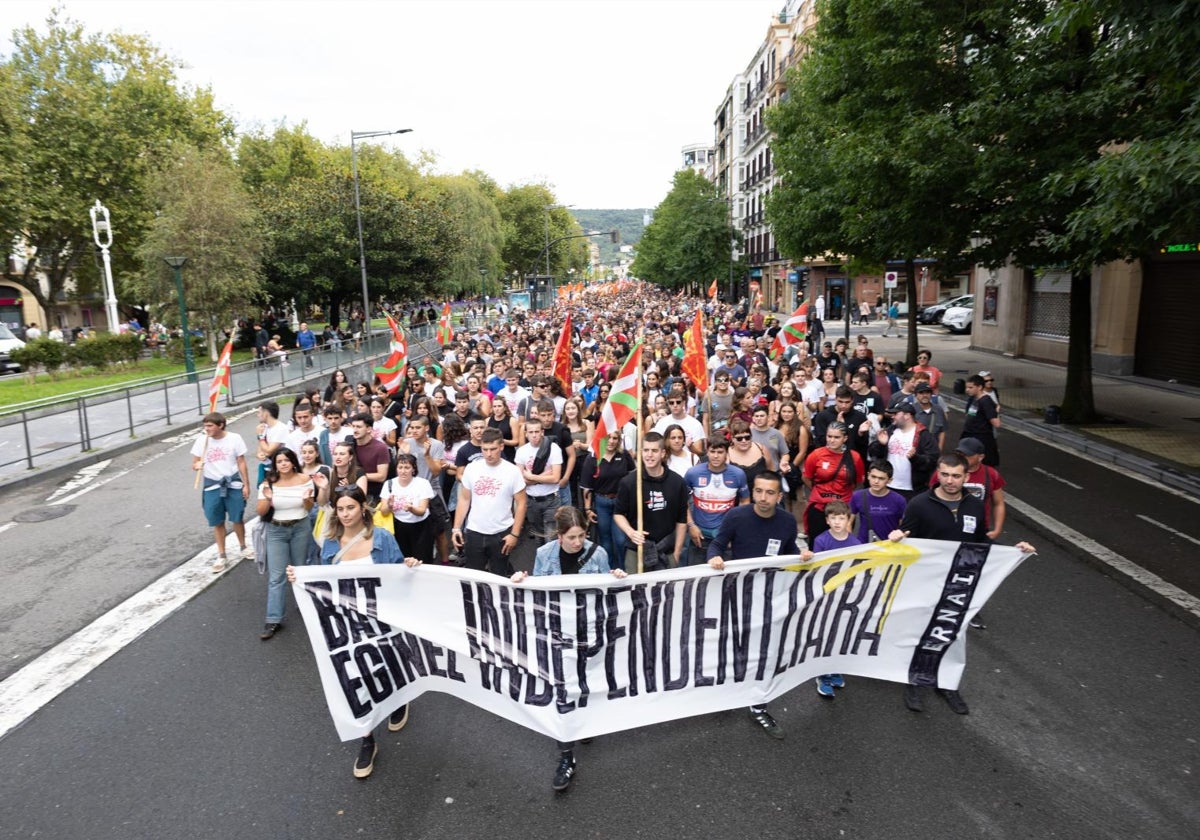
left=131, top=148, right=264, bottom=361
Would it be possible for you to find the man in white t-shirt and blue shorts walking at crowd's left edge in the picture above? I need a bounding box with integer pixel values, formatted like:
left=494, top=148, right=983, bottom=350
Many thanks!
left=192, top=412, right=254, bottom=572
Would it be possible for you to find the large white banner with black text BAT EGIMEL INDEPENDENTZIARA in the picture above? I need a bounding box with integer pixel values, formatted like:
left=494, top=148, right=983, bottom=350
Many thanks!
left=294, top=540, right=1025, bottom=740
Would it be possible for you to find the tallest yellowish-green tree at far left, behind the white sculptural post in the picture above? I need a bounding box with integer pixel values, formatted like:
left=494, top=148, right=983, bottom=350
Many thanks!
left=0, top=10, right=232, bottom=324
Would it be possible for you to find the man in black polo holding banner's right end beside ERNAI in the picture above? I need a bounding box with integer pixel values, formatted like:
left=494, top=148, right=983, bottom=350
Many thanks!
left=888, top=452, right=1037, bottom=714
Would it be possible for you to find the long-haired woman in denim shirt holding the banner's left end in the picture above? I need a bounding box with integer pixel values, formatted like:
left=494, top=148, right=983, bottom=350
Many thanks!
left=287, top=484, right=421, bottom=779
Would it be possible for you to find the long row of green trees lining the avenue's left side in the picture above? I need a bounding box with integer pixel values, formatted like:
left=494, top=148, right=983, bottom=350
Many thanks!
left=0, top=11, right=587, bottom=353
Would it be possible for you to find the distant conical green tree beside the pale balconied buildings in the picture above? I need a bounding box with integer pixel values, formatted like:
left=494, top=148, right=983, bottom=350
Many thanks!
left=632, top=169, right=740, bottom=293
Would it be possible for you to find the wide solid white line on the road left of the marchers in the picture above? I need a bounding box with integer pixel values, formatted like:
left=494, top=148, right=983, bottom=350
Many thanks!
left=0, top=518, right=258, bottom=738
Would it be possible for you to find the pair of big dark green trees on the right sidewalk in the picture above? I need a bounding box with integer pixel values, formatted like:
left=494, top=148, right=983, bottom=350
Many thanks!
left=767, top=0, right=1200, bottom=422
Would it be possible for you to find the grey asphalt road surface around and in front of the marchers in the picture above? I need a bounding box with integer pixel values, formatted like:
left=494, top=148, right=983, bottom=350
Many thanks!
left=0, top=376, right=1200, bottom=840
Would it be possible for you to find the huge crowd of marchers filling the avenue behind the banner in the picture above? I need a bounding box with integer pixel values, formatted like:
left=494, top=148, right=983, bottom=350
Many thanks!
left=192, top=283, right=1032, bottom=790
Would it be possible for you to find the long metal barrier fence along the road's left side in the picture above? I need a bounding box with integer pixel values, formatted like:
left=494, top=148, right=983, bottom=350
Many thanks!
left=0, top=324, right=437, bottom=479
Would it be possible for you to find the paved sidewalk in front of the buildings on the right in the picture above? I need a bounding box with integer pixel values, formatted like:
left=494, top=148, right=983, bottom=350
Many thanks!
left=826, top=323, right=1200, bottom=497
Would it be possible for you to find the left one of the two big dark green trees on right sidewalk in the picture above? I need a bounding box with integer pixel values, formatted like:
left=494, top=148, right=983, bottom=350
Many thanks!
left=767, top=0, right=1020, bottom=359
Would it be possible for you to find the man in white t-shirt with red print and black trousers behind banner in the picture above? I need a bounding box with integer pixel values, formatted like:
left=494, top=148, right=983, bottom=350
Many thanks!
left=450, top=428, right=526, bottom=577
